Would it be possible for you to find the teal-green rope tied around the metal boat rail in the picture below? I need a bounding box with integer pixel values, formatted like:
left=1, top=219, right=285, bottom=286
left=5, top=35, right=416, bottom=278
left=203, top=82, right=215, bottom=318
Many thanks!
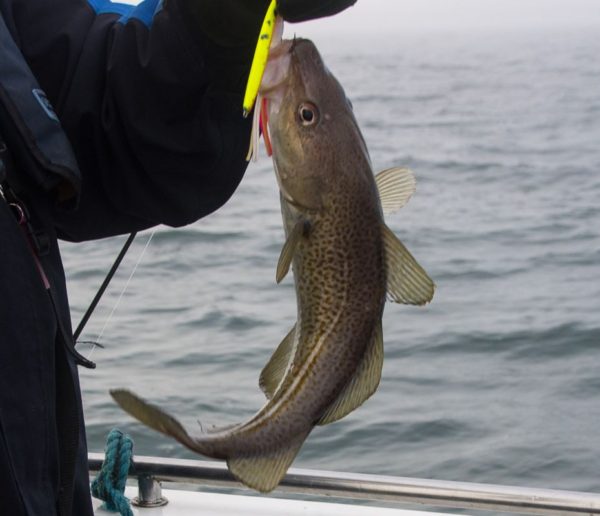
left=92, top=428, right=133, bottom=516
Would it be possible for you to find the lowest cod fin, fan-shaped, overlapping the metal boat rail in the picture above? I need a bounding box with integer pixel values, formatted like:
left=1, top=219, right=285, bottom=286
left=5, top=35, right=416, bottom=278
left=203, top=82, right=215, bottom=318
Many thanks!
left=227, top=430, right=310, bottom=493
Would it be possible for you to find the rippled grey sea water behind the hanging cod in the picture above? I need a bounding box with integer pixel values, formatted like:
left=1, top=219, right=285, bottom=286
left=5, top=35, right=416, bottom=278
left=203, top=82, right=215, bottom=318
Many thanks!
left=62, top=30, right=600, bottom=492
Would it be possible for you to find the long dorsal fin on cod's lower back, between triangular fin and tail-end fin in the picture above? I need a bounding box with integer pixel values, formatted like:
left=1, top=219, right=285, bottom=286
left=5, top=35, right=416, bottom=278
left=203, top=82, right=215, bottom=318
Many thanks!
left=318, top=321, right=383, bottom=425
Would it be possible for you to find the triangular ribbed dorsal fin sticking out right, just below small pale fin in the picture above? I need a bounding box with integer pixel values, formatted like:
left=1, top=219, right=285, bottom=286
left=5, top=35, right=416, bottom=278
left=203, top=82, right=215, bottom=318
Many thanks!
left=382, top=224, right=435, bottom=305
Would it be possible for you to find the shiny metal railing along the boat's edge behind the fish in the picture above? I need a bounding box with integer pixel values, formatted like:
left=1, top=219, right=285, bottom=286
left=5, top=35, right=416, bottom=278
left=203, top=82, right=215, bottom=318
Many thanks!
left=89, top=453, right=600, bottom=515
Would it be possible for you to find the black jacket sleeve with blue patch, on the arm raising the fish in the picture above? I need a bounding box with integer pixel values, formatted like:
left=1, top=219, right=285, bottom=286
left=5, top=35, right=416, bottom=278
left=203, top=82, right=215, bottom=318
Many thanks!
left=0, top=0, right=253, bottom=240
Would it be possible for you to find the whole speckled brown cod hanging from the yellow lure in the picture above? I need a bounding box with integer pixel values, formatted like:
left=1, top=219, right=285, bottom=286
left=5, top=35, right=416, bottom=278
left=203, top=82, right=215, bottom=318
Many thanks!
left=111, top=39, right=434, bottom=492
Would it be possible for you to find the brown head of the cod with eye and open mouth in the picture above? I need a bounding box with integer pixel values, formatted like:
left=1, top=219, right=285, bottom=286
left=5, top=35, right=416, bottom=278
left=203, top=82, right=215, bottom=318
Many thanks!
left=261, top=39, right=371, bottom=210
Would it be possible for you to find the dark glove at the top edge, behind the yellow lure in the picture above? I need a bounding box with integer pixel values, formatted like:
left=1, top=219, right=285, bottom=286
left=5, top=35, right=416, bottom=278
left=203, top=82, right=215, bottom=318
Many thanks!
left=180, top=0, right=356, bottom=47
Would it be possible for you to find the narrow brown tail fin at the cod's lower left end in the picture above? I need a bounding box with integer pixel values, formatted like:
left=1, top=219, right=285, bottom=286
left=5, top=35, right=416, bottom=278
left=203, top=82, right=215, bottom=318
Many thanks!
left=110, top=389, right=195, bottom=449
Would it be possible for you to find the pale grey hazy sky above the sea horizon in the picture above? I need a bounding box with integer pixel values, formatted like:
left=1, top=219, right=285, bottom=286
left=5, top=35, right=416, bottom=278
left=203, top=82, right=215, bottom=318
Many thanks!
left=286, top=0, right=600, bottom=37
